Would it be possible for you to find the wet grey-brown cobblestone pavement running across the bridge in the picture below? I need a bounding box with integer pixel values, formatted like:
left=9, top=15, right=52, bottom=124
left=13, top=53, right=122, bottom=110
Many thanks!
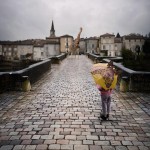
left=0, top=55, right=150, bottom=150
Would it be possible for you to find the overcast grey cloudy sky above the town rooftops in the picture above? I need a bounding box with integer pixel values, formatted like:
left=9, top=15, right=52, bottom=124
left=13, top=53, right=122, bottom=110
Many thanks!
left=0, top=0, right=150, bottom=40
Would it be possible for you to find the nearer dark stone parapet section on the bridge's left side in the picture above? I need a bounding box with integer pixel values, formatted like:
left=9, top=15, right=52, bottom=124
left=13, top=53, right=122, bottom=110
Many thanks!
left=0, top=59, right=51, bottom=92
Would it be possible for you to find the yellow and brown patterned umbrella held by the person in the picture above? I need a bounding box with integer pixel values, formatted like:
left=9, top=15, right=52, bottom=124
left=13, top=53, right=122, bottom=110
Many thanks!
left=91, top=63, right=117, bottom=90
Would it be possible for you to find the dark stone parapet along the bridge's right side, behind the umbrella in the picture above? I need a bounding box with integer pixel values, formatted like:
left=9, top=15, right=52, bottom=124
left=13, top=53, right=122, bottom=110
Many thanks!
left=87, top=53, right=150, bottom=92
